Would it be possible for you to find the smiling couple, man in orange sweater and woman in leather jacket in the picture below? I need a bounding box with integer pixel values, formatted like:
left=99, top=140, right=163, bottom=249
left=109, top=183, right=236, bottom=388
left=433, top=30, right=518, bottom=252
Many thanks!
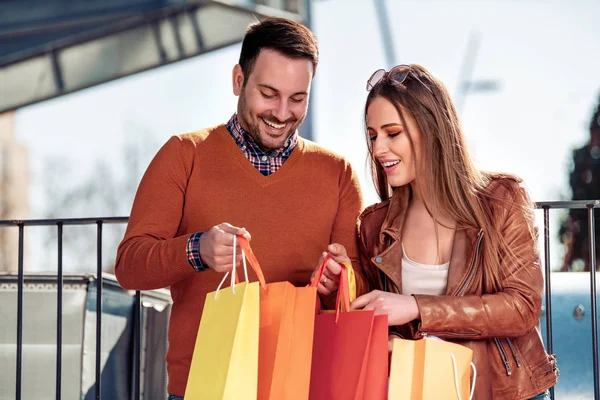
left=116, top=18, right=558, bottom=400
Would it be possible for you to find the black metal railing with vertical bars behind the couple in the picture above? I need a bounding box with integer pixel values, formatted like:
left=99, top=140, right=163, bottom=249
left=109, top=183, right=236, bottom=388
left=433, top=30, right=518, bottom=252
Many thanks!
left=0, top=200, right=600, bottom=400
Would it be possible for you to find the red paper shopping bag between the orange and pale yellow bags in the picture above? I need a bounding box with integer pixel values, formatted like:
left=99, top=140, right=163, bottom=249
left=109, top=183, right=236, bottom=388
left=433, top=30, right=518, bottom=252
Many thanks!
left=310, top=257, right=388, bottom=400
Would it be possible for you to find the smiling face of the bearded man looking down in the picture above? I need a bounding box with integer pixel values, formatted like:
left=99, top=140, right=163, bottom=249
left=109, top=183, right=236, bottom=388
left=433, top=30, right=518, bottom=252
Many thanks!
left=233, top=49, right=313, bottom=151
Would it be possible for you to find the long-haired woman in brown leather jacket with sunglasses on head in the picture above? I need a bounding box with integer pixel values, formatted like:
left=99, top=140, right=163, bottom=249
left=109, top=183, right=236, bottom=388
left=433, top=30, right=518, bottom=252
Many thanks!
left=319, top=65, right=558, bottom=400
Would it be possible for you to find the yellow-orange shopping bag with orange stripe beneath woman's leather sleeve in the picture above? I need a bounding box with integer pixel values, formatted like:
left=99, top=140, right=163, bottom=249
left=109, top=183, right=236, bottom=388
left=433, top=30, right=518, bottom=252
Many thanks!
left=389, top=339, right=477, bottom=400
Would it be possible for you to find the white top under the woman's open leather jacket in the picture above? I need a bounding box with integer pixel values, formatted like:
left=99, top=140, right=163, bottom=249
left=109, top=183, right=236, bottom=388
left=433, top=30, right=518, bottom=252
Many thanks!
left=402, top=243, right=450, bottom=296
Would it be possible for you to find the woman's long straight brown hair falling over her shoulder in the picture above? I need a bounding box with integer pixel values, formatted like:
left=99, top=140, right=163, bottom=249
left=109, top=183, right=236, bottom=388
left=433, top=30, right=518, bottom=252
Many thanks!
left=365, top=64, right=535, bottom=293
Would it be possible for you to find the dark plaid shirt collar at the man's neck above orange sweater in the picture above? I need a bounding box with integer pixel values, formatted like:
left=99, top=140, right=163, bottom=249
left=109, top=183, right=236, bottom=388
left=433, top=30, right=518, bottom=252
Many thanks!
left=226, top=114, right=298, bottom=175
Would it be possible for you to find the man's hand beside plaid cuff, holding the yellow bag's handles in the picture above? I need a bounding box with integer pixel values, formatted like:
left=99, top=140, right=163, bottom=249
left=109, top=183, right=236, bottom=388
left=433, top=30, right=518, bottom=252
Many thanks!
left=200, top=222, right=251, bottom=272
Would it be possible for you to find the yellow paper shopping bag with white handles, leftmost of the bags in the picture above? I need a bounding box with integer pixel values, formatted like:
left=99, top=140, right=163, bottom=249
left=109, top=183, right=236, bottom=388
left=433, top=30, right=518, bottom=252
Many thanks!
left=185, top=236, right=266, bottom=400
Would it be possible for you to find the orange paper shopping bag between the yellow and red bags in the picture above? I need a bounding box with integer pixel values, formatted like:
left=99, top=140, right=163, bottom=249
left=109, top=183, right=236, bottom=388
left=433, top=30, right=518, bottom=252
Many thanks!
left=238, top=236, right=317, bottom=400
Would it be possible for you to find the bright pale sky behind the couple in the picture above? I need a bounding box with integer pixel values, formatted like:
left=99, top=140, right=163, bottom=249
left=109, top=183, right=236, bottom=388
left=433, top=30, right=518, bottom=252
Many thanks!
left=10, top=0, right=600, bottom=270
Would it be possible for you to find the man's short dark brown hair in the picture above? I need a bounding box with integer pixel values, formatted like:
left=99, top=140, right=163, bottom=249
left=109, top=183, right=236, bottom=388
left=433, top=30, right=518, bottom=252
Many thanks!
left=239, top=18, right=319, bottom=85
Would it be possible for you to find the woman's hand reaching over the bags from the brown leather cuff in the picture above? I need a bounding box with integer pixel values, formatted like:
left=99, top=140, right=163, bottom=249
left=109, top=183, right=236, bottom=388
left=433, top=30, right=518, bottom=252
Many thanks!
left=350, top=290, right=420, bottom=326
